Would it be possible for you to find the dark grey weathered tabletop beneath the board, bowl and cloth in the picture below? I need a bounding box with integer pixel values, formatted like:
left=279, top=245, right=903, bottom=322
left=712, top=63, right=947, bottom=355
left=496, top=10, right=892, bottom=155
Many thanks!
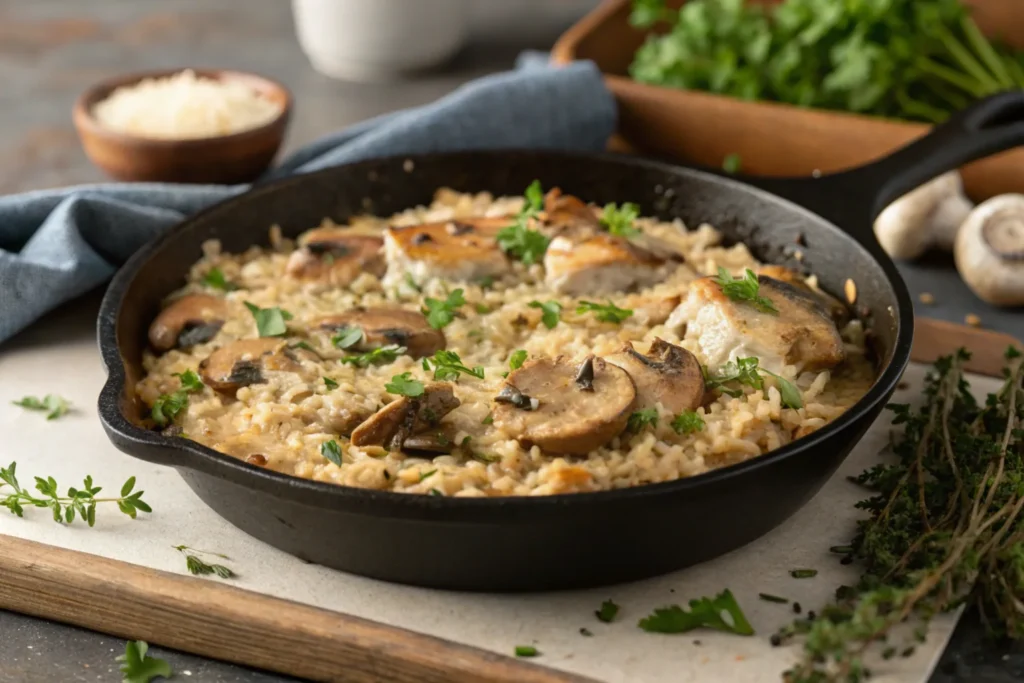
left=0, top=0, right=1024, bottom=683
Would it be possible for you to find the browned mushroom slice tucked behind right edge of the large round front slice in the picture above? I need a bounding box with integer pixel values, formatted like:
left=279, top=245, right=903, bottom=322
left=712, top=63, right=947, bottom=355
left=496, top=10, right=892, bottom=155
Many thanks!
left=607, top=339, right=705, bottom=413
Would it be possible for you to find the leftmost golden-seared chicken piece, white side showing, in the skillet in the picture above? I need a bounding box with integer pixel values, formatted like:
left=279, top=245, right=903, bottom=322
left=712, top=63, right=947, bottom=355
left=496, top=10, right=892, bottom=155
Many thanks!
left=384, top=217, right=512, bottom=287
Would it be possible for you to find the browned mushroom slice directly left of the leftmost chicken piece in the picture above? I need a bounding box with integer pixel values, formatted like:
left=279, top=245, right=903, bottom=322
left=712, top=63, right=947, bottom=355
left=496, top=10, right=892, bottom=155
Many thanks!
left=286, top=227, right=385, bottom=287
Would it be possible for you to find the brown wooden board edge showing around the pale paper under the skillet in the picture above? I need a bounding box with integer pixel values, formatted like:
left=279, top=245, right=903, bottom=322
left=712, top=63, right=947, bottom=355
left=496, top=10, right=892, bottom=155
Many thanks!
left=0, top=318, right=1007, bottom=683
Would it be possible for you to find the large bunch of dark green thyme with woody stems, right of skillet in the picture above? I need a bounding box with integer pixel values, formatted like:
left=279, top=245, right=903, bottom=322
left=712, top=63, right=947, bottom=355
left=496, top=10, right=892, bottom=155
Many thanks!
left=772, top=349, right=1024, bottom=683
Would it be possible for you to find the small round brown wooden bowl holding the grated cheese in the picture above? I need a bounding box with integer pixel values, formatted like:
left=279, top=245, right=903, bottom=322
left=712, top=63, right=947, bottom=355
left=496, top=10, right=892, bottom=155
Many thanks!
left=72, top=69, right=292, bottom=184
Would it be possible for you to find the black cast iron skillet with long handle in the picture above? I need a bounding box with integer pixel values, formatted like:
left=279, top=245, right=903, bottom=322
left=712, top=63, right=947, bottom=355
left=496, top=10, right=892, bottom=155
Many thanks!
left=98, top=91, right=1024, bottom=591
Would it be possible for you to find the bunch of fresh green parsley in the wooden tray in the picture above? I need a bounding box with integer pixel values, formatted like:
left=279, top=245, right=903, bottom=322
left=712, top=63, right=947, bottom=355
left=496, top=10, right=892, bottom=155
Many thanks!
left=630, top=0, right=1024, bottom=123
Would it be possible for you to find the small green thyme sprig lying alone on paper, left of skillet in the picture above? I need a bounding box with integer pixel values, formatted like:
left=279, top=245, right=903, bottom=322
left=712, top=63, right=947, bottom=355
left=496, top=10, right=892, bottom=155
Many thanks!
left=0, top=463, right=153, bottom=526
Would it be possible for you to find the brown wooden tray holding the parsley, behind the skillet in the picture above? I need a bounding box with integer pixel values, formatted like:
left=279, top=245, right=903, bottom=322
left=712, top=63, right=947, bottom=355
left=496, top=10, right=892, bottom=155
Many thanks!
left=551, top=0, right=1024, bottom=202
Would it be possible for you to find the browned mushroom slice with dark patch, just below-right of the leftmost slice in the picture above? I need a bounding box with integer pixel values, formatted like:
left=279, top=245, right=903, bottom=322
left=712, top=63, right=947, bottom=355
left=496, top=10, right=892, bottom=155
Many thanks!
left=199, top=337, right=308, bottom=393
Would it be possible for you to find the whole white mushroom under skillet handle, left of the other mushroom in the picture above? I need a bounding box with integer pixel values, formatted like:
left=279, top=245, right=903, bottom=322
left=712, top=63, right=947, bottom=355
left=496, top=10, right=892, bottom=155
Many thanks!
left=874, top=171, right=974, bottom=260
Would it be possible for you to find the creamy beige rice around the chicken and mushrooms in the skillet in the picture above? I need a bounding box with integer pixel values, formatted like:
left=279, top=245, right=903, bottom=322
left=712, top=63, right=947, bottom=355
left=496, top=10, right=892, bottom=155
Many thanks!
left=137, top=190, right=873, bottom=497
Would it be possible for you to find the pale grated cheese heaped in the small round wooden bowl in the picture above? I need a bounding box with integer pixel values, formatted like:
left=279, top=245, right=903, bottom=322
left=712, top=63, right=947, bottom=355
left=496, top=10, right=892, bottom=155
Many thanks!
left=92, top=70, right=282, bottom=139
